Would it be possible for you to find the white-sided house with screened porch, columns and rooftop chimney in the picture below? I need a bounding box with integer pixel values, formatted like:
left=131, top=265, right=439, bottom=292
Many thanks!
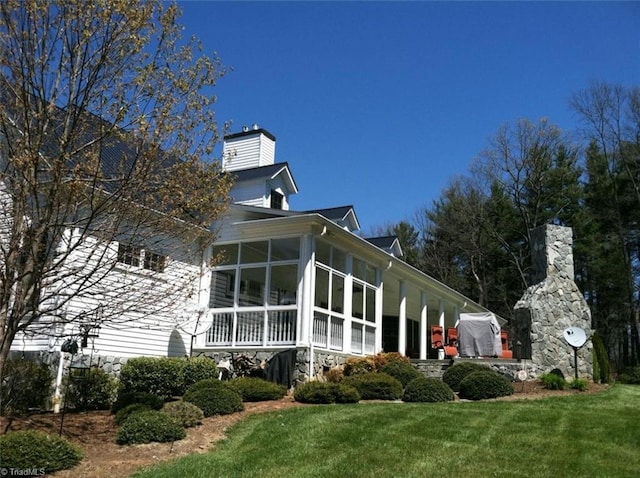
left=7, top=126, right=502, bottom=375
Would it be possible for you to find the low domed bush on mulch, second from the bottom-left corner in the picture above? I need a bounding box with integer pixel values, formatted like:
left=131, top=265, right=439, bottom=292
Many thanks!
left=116, top=410, right=187, bottom=445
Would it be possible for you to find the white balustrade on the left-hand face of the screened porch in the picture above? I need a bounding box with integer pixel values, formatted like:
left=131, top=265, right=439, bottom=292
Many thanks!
left=205, top=309, right=296, bottom=346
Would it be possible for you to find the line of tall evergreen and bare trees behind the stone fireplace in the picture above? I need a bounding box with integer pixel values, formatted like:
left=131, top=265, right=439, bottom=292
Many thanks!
left=388, top=82, right=640, bottom=369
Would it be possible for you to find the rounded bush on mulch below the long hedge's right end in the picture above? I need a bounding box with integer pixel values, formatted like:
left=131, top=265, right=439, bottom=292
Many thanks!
left=182, top=379, right=244, bottom=417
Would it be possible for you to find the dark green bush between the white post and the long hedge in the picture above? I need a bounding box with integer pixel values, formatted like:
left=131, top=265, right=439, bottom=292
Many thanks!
left=64, top=367, right=118, bottom=410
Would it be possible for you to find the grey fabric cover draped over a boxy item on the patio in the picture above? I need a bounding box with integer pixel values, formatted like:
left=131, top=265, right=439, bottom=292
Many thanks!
left=458, top=312, right=502, bottom=357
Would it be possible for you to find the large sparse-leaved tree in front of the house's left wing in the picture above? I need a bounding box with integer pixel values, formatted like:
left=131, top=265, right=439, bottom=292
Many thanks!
left=0, top=0, right=231, bottom=377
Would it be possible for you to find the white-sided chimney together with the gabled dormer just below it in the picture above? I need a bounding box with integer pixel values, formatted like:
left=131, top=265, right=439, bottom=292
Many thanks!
left=222, top=125, right=298, bottom=211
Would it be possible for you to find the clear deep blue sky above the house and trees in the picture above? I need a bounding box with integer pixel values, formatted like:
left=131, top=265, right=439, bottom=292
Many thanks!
left=180, top=1, right=640, bottom=235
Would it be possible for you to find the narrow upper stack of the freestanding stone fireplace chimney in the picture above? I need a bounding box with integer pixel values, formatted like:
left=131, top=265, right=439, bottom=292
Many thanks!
left=530, top=224, right=575, bottom=284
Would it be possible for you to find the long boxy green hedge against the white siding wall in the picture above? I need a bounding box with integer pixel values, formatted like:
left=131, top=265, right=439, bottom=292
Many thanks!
left=120, top=357, right=218, bottom=399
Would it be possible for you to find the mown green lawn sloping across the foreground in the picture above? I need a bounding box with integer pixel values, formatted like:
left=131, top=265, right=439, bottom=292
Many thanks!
left=134, top=385, right=640, bottom=478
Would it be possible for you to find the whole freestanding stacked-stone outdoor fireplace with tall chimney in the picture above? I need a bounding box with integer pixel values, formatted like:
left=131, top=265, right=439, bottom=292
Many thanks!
left=512, top=224, right=593, bottom=378
